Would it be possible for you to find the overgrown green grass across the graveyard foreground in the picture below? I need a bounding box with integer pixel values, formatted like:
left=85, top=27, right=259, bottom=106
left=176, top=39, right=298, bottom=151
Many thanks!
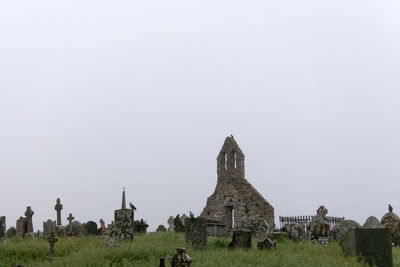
left=0, top=233, right=400, bottom=267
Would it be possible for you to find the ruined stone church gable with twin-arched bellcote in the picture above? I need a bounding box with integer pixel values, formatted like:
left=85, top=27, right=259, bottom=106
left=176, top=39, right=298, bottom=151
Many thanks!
left=200, top=136, right=275, bottom=232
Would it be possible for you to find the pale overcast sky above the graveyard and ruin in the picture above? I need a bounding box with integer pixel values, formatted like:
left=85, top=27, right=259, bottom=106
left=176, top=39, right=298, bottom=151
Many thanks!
left=0, top=0, right=400, bottom=230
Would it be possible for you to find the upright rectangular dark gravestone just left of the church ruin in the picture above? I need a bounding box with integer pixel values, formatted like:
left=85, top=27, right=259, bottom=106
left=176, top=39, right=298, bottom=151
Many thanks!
left=185, top=218, right=207, bottom=248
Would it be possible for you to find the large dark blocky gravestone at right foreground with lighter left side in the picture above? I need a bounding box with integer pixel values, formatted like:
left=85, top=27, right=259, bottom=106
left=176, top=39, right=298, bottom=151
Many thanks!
left=341, top=228, right=393, bottom=267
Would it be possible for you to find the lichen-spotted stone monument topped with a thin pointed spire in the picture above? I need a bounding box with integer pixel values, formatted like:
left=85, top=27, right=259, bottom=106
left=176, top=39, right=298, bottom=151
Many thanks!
left=114, top=188, right=135, bottom=241
